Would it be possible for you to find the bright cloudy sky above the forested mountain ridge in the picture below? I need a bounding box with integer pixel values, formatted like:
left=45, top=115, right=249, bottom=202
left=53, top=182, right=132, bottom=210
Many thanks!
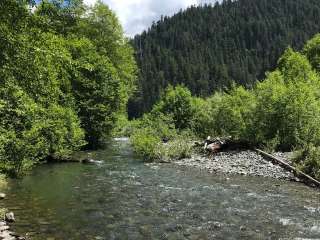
left=84, top=0, right=216, bottom=37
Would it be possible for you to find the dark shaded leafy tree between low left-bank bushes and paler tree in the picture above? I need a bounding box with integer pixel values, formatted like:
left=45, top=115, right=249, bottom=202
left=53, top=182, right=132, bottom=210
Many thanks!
left=69, top=39, right=121, bottom=147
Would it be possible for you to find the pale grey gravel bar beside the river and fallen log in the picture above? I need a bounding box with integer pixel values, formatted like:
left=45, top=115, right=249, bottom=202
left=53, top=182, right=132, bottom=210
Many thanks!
left=173, top=150, right=299, bottom=181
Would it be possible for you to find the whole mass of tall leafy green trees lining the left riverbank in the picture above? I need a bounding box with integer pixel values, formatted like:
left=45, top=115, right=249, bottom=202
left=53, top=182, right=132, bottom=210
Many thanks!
left=0, top=0, right=136, bottom=175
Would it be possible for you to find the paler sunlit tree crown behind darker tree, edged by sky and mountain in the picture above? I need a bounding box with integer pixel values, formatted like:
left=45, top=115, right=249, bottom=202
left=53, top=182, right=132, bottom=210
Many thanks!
left=78, top=0, right=137, bottom=107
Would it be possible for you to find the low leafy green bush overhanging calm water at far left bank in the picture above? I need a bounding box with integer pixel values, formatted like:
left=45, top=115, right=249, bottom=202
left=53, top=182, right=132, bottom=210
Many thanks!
left=0, top=84, right=85, bottom=175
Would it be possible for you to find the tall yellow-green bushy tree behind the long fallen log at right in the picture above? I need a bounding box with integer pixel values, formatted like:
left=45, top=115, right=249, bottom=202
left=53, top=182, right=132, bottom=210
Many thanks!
left=253, top=49, right=320, bottom=150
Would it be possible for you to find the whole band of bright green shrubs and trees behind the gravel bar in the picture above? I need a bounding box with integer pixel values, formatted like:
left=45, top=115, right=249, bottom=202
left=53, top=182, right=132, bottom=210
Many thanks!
left=128, top=34, right=320, bottom=180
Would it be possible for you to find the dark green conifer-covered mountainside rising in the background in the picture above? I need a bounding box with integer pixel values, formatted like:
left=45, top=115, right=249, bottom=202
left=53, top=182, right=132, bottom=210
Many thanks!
left=128, top=0, right=320, bottom=117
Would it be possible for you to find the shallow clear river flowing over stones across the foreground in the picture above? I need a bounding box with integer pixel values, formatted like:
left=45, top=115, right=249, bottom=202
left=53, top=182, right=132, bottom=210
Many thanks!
left=1, top=139, right=320, bottom=240
